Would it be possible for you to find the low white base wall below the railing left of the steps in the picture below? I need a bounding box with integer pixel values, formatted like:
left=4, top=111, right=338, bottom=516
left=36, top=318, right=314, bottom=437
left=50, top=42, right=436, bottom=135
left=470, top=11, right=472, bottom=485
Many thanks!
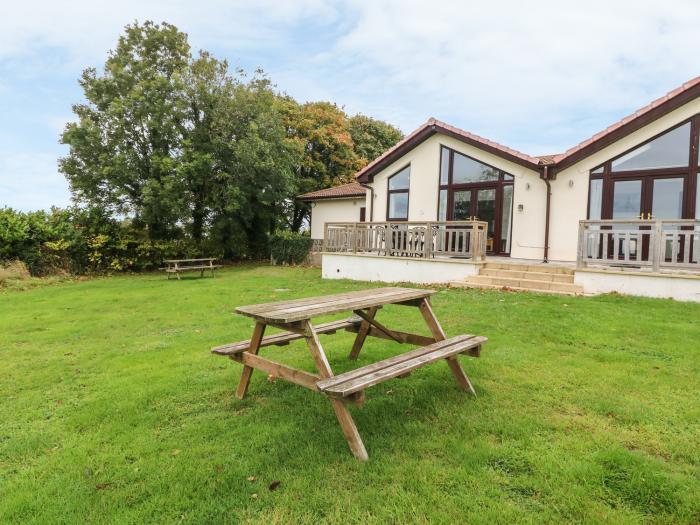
left=321, top=253, right=481, bottom=284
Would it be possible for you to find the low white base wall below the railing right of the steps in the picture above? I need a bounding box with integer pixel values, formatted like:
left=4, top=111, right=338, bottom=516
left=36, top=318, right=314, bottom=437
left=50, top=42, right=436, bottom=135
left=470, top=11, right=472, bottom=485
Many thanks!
left=574, top=269, right=700, bottom=302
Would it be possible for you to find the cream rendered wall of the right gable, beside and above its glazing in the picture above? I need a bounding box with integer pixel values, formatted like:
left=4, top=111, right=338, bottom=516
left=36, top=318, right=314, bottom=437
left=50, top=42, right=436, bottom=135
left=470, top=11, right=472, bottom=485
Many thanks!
left=548, top=99, right=700, bottom=261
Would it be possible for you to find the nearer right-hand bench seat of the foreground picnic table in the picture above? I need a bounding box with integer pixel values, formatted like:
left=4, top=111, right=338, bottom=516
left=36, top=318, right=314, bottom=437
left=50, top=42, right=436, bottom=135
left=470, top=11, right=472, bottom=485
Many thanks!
left=316, top=335, right=487, bottom=397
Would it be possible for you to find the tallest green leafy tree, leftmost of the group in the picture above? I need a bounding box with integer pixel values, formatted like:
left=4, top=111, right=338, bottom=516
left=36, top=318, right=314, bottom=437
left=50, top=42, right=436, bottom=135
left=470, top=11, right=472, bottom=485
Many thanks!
left=59, top=22, right=190, bottom=239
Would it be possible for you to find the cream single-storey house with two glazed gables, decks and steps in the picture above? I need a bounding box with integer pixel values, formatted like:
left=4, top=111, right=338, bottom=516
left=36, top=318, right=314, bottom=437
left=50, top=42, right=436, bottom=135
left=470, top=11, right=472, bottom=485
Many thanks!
left=301, top=77, right=700, bottom=301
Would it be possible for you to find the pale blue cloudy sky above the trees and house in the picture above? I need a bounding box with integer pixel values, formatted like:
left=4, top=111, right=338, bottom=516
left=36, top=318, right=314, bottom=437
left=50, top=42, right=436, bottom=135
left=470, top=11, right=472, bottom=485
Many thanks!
left=0, top=0, right=700, bottom=210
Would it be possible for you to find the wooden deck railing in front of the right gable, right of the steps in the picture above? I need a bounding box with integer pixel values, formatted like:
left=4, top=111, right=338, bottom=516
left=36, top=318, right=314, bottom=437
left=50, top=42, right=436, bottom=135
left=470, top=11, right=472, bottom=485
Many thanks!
left=578, top=219, right=700, bottom=272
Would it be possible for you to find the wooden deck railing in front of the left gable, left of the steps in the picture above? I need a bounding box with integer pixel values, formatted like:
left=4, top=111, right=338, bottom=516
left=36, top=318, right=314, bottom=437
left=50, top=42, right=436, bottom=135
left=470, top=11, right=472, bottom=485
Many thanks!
left=323, top=221, right=488, bottom=260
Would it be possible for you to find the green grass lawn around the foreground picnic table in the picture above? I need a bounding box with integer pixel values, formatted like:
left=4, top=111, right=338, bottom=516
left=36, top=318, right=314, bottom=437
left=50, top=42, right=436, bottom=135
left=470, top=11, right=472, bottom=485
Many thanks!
left=0, top=266, right=700, bottom=524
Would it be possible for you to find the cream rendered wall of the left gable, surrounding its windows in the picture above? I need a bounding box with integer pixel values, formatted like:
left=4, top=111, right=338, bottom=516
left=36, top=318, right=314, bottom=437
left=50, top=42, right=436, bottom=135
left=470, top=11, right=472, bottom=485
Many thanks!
left=367, top=133, right=544, bottom=259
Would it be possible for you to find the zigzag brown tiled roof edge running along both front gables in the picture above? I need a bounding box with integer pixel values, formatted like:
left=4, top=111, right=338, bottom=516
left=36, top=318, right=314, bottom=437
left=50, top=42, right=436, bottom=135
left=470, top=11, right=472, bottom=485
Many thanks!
left=355, top=73, right=700, bottom=182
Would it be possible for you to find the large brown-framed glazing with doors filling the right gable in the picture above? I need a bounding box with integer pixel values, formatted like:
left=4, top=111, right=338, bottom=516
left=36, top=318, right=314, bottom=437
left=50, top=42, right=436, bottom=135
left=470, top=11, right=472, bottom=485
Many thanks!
left=588, top=115, right=700, bottom=220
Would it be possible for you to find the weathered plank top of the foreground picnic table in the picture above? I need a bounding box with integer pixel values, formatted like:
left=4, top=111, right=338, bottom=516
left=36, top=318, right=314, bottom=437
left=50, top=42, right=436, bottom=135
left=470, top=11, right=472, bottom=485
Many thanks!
left=236, top=286, right=435, bottom=323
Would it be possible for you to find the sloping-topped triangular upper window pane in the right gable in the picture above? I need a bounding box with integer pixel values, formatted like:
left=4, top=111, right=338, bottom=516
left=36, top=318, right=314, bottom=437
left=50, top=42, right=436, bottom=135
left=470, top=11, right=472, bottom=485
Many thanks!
left=612, top=122, right=690, bottom=171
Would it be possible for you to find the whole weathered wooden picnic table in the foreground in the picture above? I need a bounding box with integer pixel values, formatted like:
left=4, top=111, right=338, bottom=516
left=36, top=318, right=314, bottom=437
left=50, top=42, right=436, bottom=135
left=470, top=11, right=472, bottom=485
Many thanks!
left=212, top=287, right=487, bottom=460
